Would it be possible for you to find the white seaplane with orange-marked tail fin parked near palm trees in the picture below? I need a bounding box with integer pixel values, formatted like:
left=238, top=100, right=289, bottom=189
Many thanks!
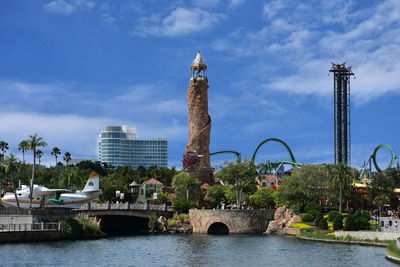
left=1, top=172, right=102, bottom=209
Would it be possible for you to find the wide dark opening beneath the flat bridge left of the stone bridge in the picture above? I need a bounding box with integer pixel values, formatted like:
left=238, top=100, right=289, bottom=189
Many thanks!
left=97, top=215, right=149, bottom=234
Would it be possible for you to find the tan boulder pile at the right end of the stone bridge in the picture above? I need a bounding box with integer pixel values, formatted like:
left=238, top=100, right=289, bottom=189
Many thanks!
left=265, top=206, right=301, bottom=235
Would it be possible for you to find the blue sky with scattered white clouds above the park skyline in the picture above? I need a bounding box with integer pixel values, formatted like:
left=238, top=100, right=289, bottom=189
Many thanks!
left=0, top=0, right=400, bottom=171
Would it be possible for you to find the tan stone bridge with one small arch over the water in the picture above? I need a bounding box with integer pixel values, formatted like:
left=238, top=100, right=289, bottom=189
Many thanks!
left=189, top=209, right=275, bottom=234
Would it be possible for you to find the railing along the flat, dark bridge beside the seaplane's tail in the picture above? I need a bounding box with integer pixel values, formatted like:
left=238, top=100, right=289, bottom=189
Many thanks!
left=76, top=203, right=172, bottom=211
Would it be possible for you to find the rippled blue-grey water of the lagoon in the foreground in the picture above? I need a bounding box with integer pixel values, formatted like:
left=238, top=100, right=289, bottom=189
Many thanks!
left=0, top=235, right=396, bottom=267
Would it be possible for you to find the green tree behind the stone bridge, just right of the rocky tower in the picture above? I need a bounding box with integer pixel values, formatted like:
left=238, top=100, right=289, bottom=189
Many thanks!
left=216, top=159, right=258, bottom=208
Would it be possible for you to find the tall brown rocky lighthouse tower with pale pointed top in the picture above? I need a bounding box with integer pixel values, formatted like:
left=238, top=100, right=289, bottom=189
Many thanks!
left=183, top=51, right=214, bottom=184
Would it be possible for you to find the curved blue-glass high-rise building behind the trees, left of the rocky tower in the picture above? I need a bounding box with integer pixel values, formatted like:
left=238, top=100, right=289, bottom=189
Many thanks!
left=97, top=126, right=168, bottom=169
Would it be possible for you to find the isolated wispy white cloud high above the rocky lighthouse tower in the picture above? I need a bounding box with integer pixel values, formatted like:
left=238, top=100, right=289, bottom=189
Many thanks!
left=133, top=7, right=224, bottom=37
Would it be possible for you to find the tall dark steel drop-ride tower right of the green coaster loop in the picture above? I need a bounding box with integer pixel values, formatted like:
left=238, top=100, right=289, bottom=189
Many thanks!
left=329, top=63, right=354, bottom=166
